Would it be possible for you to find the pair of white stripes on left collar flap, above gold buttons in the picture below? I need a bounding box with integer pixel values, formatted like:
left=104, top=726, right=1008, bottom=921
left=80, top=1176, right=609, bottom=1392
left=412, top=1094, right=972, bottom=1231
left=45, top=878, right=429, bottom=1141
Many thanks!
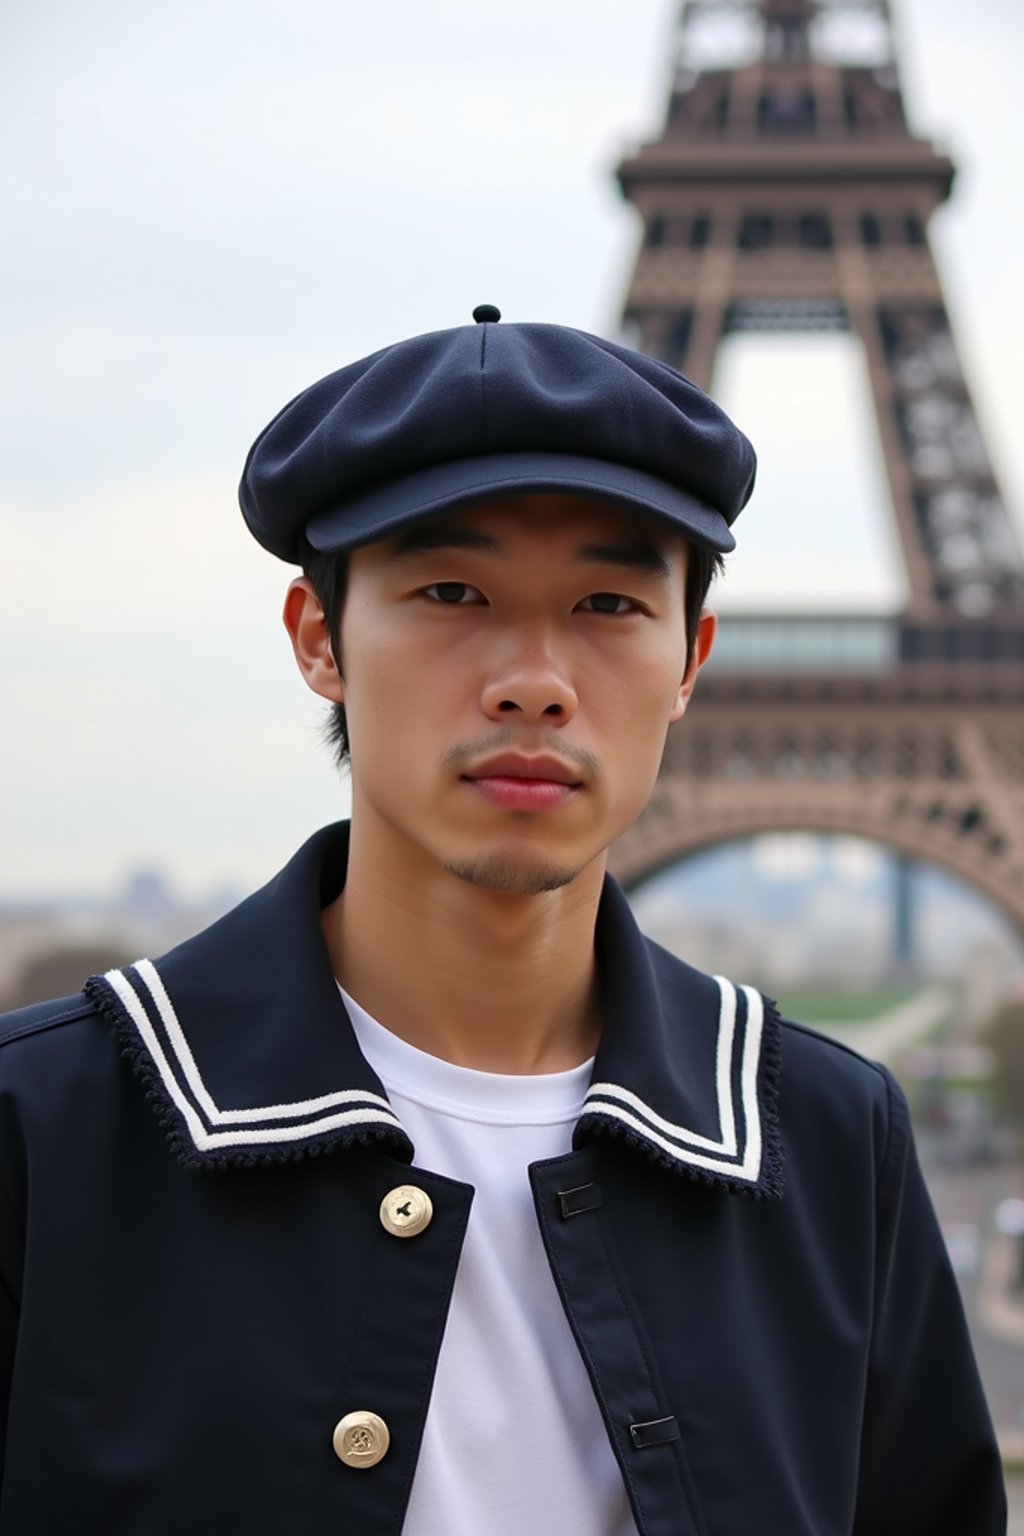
left=104, top=960, right=402, bottom=1152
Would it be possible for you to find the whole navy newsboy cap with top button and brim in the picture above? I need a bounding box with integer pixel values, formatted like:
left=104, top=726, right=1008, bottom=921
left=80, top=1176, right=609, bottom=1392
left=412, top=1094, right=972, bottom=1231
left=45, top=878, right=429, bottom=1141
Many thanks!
left=239, top=304, right=757, bottom=562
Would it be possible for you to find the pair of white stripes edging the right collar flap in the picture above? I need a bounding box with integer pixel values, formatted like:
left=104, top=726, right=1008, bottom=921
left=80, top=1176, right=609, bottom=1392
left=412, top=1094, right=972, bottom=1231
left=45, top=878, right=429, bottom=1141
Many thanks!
left=583, top=975, right=765, bottom=1184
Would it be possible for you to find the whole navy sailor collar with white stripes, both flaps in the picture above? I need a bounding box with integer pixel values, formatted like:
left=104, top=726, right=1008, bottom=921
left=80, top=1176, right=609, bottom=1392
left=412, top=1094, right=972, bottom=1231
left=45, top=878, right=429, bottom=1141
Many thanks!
left=86, top=823, right=783, bottom=1198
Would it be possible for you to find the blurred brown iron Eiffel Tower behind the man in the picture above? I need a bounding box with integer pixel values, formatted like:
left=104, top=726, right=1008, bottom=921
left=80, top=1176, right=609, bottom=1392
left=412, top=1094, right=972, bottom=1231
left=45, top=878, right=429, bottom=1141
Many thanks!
left=613, top=0, right=1024, bottom=932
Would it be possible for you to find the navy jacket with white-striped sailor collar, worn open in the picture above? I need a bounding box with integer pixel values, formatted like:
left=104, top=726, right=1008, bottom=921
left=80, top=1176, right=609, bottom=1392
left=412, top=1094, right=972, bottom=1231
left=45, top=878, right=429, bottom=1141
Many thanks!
left=0, top=828, right=1006, bottom=1536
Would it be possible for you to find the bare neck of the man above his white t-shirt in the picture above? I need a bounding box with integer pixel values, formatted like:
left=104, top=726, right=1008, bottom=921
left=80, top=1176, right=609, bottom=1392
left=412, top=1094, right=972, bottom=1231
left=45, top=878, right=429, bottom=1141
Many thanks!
left=324, top=826, right=605, bottom=1074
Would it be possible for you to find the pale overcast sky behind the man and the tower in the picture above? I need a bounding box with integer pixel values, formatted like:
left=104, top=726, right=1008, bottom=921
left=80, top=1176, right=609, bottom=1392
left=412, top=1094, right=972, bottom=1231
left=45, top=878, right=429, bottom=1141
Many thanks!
left=0, top=0, right=1024, bottom=897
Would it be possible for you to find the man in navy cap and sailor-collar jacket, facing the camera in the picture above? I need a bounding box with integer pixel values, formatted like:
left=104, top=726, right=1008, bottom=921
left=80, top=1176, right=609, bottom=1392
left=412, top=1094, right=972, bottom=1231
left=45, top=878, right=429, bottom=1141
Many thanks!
left=0, top=306, right=1006, bottom=1536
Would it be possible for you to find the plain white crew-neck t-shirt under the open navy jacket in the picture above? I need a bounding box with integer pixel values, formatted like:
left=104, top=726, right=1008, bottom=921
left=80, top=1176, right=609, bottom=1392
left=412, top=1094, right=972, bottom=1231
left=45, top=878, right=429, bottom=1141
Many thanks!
left=342, top=989, right=636, bottom=1536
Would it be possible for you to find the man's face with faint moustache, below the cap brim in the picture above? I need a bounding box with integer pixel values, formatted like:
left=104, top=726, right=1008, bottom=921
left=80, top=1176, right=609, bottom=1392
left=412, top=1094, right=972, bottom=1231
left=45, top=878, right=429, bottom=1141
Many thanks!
left=322, top=495, right=714, bottom=894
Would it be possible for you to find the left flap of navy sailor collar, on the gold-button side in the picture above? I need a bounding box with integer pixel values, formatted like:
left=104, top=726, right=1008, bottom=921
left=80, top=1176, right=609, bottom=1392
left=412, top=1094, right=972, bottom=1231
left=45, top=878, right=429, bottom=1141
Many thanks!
left=86, top=826, right=413, bottom=1167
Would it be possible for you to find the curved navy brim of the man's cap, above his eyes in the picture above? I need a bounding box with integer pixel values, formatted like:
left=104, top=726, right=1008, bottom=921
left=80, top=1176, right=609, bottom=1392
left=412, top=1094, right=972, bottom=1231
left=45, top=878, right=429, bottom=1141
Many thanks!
left=306, top=453, right=735, bottom=554
